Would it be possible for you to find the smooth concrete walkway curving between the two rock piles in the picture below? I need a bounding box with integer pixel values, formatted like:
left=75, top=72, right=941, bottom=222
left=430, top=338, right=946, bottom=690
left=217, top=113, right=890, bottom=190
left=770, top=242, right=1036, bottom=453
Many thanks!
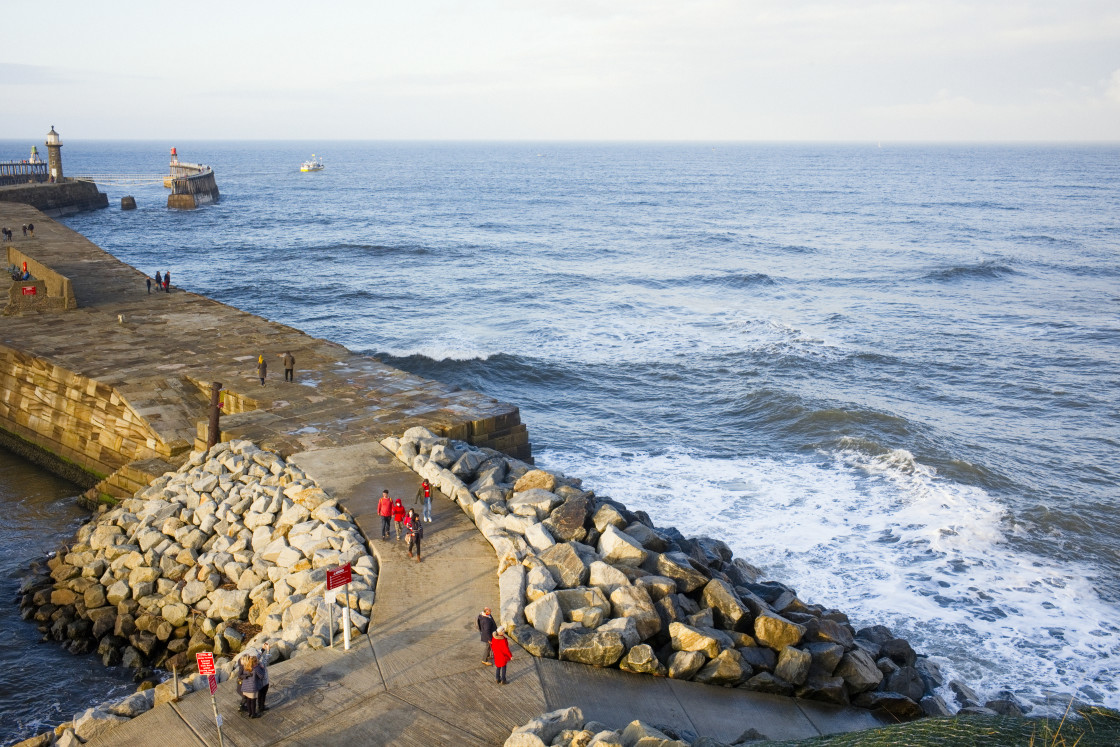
left=90, top=443, right=881, bottom=747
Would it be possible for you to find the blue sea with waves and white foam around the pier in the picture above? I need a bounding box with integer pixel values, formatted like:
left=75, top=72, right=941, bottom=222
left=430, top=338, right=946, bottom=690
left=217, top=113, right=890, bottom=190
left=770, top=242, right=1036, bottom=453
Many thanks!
left=0, top=138, right=1120, bottom=743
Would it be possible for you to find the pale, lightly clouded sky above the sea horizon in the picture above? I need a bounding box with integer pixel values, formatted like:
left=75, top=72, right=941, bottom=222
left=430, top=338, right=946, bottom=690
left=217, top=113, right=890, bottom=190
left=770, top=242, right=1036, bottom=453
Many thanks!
left=0, top=0, right=1120, bottom=142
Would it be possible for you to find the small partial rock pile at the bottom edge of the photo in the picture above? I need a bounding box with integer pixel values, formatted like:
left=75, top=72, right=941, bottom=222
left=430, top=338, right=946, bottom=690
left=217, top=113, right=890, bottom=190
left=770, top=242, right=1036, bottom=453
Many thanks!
left=504, top=708, right=766, bottom=747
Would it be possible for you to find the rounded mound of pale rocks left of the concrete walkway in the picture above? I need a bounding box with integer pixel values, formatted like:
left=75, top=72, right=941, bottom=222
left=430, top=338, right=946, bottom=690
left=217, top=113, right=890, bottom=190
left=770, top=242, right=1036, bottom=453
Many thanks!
left=21, top=441, right=377, bottom=673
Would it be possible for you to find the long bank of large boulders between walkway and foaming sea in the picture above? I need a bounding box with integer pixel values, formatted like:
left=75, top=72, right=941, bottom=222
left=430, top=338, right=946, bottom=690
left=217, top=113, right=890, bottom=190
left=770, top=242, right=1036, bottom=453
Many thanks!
left=382, top=428, right=963, bottom=719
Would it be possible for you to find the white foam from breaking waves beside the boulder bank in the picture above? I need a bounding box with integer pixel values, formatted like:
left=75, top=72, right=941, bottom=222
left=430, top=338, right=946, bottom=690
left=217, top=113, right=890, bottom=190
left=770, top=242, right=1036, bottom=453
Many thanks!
left=539, top=448, right=1120, bottom=708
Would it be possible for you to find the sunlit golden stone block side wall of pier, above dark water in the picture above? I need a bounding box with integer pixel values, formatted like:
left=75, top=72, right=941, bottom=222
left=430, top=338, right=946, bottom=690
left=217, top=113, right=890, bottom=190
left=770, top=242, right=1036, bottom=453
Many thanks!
left=0, top=345, right=171, bottom=477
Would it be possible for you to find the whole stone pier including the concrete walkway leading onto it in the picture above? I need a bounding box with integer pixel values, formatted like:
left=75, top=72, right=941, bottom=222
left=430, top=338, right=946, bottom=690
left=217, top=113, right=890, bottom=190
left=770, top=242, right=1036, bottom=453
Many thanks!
left=0, top=204, right=880, bottom=746
